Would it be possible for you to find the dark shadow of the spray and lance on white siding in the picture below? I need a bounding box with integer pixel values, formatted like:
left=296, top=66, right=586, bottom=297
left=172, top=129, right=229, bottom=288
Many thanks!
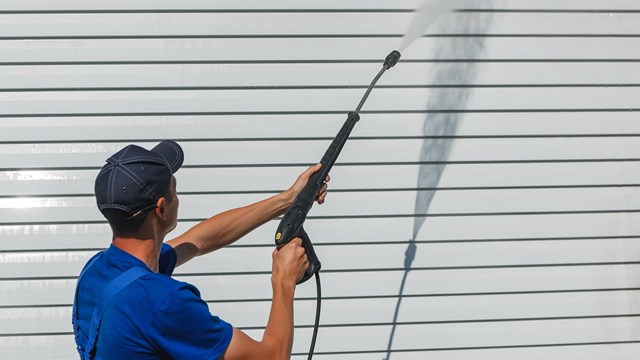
left=386, top=0, right=492, bottom=360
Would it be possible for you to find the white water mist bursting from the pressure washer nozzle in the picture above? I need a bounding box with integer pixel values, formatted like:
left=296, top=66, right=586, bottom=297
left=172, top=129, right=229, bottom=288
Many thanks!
left=398, top=0, right=464, bottom=52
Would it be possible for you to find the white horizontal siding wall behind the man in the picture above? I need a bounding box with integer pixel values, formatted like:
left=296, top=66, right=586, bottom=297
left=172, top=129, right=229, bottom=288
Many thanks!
left=0, top=0, right=640, bottom=360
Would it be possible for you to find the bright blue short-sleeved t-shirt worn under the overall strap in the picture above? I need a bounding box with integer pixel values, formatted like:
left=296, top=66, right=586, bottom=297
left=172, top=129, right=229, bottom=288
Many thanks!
left=74, top=244, right=233, bottom=360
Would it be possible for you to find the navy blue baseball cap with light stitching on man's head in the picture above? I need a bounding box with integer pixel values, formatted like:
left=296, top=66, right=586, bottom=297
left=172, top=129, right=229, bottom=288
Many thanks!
left=95, top=140, right=184, bottom=220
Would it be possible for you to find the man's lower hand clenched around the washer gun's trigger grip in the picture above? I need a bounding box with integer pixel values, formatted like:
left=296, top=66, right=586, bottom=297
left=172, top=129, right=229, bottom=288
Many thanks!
left=271, top=238, right=309, bottom=286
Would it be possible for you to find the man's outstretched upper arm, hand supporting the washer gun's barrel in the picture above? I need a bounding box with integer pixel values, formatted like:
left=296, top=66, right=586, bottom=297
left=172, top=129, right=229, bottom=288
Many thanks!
left=167, top=164, right=329, bottom=266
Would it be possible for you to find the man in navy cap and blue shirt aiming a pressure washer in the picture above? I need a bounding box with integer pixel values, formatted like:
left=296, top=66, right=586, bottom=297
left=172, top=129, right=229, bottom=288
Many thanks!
left=73, top=140, right=329, bottom=360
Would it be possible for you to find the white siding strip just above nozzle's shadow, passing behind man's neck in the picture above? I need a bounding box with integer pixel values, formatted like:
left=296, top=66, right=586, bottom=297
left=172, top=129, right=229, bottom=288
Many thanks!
left=0, top=212, right=640, bottom=250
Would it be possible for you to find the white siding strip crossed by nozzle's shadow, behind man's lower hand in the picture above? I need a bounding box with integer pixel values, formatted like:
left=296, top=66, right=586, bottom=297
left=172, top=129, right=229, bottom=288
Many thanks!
left=5, top=233, right=640, bottom=279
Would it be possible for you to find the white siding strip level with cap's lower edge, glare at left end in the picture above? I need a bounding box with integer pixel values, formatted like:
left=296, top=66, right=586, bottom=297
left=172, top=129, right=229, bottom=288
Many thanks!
left=0, top=183, right=640, bottom=225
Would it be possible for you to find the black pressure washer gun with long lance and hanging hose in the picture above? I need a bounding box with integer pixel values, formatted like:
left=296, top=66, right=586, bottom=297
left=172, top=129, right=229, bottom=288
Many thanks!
left=275, top=50, right=400, bottom=360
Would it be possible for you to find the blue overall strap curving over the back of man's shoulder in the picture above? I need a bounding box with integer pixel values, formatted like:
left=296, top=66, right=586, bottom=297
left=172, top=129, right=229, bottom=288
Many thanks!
left=74, top=267, right=149, bottom=360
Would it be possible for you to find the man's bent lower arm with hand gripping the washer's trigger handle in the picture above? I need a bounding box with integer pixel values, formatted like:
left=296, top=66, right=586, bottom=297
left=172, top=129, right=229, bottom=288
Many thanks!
left=222, top=238, right=309, bottom=360
